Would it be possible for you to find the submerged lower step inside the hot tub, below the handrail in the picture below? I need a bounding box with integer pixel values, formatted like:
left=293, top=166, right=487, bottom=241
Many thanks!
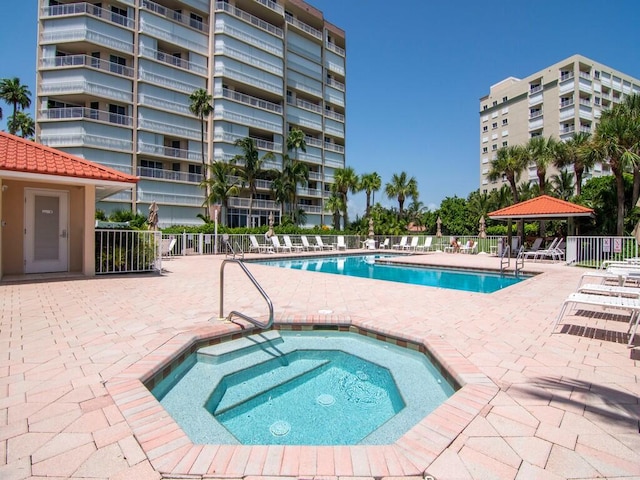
left=207, top=358, right=330, bottom=415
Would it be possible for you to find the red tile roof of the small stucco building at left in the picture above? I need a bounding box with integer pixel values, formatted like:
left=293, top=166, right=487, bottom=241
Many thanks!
left=0, top=132, right=138, bottom=183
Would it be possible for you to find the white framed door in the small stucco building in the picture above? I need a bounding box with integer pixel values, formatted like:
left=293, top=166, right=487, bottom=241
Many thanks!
left=24, top=188, right=69, bottom=273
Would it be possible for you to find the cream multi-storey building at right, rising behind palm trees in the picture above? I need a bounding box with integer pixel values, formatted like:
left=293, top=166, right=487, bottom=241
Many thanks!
left=480, top=55, right=640, bottom=192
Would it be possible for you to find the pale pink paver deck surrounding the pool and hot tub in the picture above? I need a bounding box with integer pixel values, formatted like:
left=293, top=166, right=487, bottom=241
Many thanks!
left=0, top=251, right=640, bottom=480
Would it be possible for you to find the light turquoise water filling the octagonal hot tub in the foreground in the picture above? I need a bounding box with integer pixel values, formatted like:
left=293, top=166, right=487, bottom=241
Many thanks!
left=152, top=331, right=454, bottom=445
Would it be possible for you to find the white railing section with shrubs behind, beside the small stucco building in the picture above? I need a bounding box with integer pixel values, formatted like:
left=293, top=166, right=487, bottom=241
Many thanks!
left=95, top=229, right=162, bottom=275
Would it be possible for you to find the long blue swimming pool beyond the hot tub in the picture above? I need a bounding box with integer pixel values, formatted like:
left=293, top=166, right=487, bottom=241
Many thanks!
left=247, top=255, right=528, bottom=293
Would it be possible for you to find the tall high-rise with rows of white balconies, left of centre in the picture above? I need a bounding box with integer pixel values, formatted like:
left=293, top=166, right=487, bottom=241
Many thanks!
left=36, top=0, right=346, bottom=226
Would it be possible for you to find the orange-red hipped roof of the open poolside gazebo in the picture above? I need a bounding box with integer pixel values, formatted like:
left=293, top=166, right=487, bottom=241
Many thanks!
left=489, top=195, right=593, bottom=220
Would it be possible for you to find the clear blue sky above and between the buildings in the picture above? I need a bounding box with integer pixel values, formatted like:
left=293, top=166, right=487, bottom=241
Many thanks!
left=0, top=0, right=640, bottom=218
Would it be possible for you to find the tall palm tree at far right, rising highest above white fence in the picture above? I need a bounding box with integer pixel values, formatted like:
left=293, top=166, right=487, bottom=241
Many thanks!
left=593, top=105, right=640, bottom=236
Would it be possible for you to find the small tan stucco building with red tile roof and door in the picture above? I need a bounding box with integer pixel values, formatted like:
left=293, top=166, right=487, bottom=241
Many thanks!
left=0, top=132, right=138, bottom=280
